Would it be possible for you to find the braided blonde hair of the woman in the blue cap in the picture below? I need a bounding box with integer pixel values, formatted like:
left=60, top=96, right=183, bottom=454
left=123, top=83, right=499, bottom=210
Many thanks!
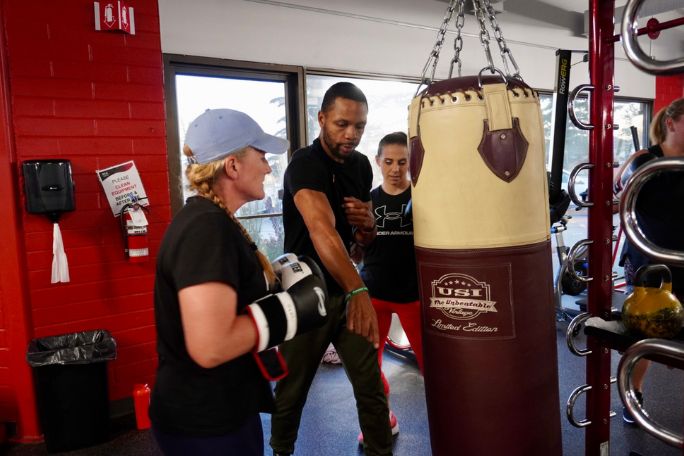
left=183, top=144, right=276, bottom=288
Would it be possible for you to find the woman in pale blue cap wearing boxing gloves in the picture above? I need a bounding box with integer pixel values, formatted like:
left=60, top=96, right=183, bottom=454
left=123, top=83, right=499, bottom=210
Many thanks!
left=150, top=109, right=325, bottom=456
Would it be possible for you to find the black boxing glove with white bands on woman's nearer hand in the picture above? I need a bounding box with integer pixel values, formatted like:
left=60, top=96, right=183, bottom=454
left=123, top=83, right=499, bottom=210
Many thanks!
left=247, top=273, right=328, bottom=352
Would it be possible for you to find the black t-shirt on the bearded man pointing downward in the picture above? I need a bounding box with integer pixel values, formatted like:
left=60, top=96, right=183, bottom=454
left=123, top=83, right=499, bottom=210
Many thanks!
left=283, top=139, right=373, bottom=293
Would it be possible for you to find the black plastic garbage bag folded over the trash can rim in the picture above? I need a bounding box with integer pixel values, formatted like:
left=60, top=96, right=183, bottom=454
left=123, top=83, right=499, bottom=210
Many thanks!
left=26, top=329, right=116, bottom=367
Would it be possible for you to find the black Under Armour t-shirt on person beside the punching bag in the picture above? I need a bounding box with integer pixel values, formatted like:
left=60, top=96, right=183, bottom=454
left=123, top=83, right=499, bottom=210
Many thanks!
left=361, top=186, right=418, bottom=302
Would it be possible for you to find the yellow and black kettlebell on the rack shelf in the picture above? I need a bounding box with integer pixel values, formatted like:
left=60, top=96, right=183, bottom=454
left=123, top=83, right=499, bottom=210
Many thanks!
left=622, top=264, right=684, bottom=338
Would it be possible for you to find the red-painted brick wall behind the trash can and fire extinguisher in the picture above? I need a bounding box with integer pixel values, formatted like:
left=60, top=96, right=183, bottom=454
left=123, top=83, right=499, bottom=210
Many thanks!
left=0, top=0, right=170, bottom=432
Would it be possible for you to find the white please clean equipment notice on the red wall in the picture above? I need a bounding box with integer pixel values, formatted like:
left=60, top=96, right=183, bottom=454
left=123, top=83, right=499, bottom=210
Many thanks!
left=95, top=160, right=150, bottom=217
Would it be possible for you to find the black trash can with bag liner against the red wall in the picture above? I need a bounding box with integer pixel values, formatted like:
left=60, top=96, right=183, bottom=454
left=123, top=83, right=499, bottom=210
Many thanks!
left=27, top=329, right=116, bottom=453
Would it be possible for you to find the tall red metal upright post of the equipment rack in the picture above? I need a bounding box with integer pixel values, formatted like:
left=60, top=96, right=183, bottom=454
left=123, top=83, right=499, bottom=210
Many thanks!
left=585, top=0, right=615, bottom=456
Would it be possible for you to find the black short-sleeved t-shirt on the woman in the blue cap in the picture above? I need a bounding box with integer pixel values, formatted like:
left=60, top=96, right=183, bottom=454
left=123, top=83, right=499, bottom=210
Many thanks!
left=150, top=197, right=273, bottom=436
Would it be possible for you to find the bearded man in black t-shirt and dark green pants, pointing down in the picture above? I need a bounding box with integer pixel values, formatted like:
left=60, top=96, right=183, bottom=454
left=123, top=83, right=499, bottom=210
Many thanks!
left=270, top=82, right=392, bottom=456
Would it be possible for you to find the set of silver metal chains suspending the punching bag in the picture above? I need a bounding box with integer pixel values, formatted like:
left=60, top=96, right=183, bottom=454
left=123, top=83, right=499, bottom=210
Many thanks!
left=416, top=0, right=522, bottom=95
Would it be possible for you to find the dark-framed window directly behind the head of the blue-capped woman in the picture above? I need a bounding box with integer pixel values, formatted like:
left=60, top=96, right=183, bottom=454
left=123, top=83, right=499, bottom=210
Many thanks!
left=166, top=56, right=301, bottom=258
